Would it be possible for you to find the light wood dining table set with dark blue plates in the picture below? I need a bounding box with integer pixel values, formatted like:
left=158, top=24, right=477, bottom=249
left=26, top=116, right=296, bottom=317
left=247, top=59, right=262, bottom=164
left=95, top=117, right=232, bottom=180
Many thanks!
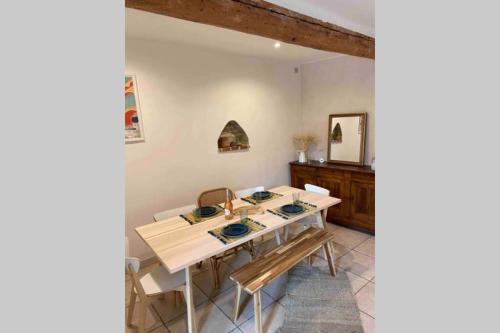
left=135, top=185, right=341, bottom=333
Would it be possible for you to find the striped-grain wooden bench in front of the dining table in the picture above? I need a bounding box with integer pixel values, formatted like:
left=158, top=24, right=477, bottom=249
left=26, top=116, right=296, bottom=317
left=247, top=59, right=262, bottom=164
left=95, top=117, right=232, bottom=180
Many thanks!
left=230, top=227, right=336, bottom=333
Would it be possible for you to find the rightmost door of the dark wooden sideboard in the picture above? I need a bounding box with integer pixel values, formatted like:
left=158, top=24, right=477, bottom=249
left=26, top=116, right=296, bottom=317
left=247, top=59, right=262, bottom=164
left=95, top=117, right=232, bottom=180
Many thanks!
left=350, top=180, right=375, bottom=232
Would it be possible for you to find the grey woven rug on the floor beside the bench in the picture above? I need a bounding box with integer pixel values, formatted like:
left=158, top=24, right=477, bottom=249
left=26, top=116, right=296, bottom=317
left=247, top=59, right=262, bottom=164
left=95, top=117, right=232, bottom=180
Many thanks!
left=278, top=264, right=363, bottom=333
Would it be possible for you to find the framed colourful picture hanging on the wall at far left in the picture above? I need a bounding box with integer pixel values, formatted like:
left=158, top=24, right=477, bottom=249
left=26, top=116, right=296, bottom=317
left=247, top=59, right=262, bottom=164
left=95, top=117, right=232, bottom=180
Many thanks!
left=125, top=75, right=144, bottom=142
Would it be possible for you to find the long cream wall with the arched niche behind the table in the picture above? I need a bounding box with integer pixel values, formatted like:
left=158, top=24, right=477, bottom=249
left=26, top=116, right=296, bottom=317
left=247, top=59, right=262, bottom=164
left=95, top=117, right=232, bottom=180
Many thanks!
left=125, top=39, right=302, bottom=258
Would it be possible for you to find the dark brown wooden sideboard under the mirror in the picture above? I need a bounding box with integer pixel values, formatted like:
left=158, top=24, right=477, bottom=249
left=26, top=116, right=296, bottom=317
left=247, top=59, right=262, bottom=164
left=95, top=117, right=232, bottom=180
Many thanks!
left=290, top=161, right=375, bottom=234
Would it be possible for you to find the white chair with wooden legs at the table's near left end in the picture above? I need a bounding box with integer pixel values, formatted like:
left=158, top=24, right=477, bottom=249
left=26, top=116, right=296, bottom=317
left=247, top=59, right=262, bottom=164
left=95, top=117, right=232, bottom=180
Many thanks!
left=125, top=237, right=189, bottom=333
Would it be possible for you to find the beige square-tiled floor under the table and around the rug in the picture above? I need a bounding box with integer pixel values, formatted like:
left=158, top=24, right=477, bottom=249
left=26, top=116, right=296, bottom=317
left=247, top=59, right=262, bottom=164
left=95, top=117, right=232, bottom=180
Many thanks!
left=125, top=223, right=375, bottom=333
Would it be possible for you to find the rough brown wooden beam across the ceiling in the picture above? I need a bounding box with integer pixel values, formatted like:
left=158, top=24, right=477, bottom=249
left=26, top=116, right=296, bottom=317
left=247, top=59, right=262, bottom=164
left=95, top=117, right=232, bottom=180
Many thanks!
left=125, top=0, right=375, bottom=59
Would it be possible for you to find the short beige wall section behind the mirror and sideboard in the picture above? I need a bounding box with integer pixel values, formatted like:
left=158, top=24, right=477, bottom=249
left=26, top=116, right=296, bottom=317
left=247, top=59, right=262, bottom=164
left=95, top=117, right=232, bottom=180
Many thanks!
left=301, top=56, right=375, bottom=165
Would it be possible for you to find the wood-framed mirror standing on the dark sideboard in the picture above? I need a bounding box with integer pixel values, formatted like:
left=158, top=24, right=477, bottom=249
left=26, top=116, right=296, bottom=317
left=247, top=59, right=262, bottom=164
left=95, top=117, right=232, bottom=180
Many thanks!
left=328, top=113, right=366, bottom=165
